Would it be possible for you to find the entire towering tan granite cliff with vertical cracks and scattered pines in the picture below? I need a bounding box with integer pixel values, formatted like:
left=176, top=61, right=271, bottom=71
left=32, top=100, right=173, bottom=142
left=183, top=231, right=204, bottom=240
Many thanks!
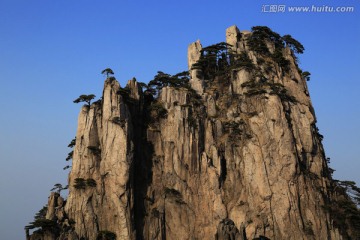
left=28, top=26, right=360, bottom=240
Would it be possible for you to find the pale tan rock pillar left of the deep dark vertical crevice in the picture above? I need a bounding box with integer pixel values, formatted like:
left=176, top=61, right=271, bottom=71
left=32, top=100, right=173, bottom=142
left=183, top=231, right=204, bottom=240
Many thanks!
left=66, top=80, right=136, bottom=239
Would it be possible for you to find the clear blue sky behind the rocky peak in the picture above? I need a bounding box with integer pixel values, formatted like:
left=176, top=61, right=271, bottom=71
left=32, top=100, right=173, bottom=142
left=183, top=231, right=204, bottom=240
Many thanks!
left=0, top=0, right=360, bottom=240
